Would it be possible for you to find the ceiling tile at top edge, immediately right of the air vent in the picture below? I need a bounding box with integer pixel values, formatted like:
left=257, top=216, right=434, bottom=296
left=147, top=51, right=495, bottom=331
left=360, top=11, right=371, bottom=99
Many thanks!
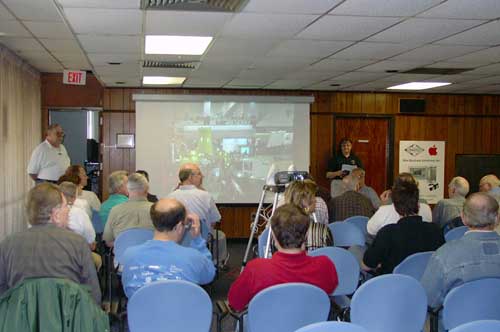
left=243, top=0, right=342, bottom=14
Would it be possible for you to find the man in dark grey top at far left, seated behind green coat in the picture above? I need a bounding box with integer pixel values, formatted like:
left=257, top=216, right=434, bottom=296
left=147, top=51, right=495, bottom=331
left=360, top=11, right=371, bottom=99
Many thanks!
left=0, top=183, right=101, bottom=303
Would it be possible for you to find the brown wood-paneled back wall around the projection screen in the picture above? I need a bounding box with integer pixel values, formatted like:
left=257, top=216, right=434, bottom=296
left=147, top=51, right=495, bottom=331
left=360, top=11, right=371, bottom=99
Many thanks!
left=43, top=79, right=500, bottom=237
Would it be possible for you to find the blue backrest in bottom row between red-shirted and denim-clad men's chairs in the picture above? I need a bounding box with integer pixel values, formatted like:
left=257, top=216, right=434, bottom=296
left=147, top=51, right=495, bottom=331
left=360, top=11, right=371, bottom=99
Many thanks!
left=351, top=274, right=427, bottom=332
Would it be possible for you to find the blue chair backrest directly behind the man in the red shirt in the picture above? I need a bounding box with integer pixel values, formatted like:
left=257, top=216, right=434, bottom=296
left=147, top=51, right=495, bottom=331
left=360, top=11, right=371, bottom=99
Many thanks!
left=247, top=283, right=330, bottom=332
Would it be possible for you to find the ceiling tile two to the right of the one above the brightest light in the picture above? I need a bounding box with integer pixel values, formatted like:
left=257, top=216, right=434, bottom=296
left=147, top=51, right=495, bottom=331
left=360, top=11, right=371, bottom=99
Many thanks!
left=296, top=15, right=401, bottom=41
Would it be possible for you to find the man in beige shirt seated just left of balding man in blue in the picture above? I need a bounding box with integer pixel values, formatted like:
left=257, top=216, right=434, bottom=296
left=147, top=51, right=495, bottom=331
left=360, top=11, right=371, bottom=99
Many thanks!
left=102, top=173, right=153, bottom=247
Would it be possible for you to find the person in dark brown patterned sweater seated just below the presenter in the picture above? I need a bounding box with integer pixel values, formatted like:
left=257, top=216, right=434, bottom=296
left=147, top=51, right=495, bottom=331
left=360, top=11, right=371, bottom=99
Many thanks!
left=328, top=174, right=375, bottom=222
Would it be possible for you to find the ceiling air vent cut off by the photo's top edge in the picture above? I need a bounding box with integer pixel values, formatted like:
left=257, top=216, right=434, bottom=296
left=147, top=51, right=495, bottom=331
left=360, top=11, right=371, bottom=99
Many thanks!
left=141, top=0, right=248, bottom=12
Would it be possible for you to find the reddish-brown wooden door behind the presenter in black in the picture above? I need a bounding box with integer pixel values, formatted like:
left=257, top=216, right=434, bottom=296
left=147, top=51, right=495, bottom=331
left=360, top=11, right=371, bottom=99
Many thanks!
left=332, top=117, right=392, bottom=194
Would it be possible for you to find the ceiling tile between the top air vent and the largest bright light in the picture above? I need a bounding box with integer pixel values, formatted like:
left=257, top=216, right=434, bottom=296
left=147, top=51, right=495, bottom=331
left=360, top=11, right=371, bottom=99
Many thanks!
left=145, top=10, right=233, bottom=36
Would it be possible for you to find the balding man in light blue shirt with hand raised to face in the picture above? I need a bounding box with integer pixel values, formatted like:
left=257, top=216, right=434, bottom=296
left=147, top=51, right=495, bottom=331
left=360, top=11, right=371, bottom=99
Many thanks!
left=122, top=198, right=215, bottom=298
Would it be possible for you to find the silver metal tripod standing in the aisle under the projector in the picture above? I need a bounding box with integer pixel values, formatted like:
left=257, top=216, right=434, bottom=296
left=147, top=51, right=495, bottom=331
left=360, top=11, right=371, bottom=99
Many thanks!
left=241, top=184, right=285, bottom=271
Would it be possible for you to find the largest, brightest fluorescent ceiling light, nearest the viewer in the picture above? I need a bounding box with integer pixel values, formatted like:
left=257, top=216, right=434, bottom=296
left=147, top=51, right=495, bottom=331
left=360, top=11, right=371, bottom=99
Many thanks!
left=146, top=36, right=213, bottom=55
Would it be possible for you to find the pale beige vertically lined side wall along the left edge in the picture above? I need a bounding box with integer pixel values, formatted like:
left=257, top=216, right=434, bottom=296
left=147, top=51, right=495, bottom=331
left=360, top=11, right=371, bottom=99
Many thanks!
left=0, top=45, right=41, bottom=241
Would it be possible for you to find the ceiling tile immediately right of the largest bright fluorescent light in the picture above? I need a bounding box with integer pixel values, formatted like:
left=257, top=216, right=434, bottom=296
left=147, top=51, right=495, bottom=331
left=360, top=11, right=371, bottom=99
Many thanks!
left=206, top=38, right=280, bottom=57
